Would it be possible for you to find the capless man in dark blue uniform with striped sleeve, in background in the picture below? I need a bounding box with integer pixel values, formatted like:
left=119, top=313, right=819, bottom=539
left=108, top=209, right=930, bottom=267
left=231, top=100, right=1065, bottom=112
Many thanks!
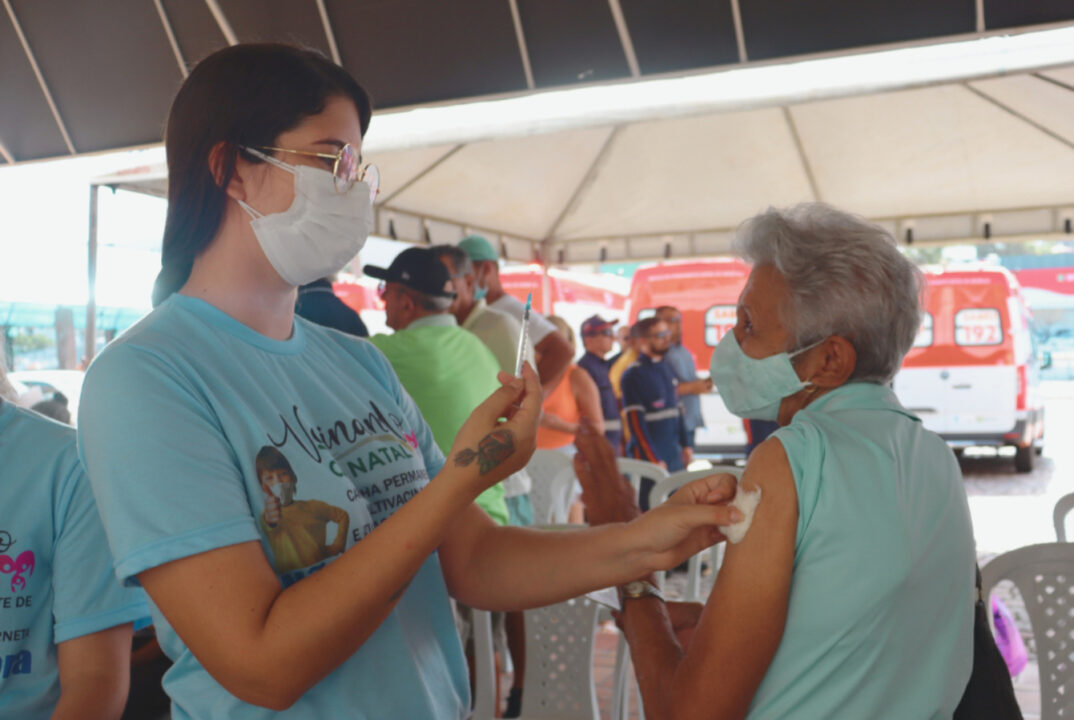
left=623, top=318, right=694, bottom=509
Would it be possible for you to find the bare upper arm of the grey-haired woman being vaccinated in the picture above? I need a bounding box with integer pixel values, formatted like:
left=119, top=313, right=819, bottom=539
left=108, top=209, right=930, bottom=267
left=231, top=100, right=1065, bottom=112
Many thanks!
left=671, top=438, right=798, bottom=718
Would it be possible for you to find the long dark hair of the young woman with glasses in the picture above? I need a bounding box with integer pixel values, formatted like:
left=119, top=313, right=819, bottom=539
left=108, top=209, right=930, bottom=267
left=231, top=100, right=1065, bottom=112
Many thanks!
left=153, top=43, right=372, bottom=306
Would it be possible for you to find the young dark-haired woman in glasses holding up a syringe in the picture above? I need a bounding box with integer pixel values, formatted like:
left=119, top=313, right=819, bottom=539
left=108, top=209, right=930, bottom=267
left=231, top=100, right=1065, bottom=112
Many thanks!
left=79, top=45, right=735, bottom=720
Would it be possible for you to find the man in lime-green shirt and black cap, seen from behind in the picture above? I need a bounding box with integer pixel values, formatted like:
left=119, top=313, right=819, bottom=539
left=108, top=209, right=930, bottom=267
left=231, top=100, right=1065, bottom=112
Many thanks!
left=365, top=247, right=508, bottom=525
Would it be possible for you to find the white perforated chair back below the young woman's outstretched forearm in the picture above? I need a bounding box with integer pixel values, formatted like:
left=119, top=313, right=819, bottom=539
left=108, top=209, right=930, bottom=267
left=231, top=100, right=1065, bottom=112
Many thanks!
left=521, top=597, right=600, bottom=720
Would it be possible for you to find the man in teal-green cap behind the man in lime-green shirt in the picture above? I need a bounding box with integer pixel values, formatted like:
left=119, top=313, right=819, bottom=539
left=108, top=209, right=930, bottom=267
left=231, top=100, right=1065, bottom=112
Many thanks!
left=459, top=235, right=575, bottom=395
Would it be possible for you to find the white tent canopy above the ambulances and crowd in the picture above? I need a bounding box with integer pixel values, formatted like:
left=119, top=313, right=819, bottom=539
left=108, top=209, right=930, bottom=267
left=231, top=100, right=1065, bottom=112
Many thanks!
left=95, top=26, right=1074, bottom=263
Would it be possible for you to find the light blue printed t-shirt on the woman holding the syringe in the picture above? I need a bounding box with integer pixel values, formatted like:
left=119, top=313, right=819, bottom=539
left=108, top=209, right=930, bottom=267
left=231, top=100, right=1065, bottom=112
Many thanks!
left=78, top=294, right=469, bottom=720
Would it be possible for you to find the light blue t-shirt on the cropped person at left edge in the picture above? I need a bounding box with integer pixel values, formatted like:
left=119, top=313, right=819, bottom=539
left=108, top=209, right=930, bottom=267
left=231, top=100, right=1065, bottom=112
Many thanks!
left=0, top=403, right=149, bottom=720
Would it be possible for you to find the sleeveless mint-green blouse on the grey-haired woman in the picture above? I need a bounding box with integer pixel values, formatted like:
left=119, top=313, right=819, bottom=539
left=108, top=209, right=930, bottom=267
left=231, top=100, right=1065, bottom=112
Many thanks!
left=748, top=383, right=975, bottom=720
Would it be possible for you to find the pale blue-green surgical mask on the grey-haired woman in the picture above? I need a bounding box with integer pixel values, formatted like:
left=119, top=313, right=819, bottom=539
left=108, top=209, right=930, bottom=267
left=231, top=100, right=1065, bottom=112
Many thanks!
left=709, top=332, right=824, bottom=420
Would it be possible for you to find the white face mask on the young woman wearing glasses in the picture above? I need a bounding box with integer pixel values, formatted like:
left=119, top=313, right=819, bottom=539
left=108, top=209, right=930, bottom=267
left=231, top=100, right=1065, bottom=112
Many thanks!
left=237, top=147, right=373, bottom=285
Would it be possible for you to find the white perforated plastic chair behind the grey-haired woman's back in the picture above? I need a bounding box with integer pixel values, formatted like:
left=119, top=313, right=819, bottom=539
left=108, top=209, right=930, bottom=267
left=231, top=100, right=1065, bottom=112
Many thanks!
left=981, top=543, right=1074, bottom=720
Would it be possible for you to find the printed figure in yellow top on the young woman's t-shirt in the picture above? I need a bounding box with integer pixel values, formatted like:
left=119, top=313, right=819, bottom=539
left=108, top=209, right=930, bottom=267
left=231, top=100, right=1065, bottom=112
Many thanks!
left=255, top=445, right=350, bottom=574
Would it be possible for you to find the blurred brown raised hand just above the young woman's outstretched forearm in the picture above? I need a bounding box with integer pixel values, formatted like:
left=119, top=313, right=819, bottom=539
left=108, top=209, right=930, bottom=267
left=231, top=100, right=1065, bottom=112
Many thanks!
left=575, top=417, right=641, bottom=525
